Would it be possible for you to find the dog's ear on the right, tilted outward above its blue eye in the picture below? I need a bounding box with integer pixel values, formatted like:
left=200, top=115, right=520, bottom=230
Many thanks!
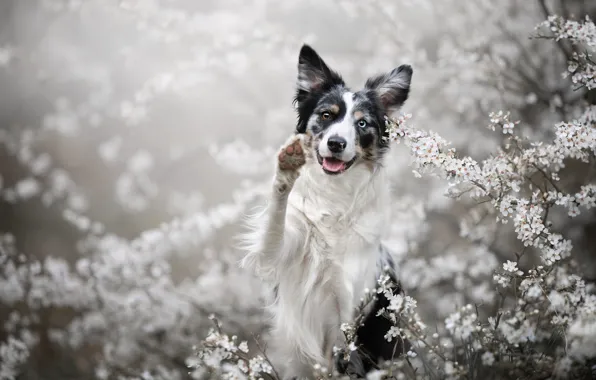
left=364, top=65, right=413, bottom=115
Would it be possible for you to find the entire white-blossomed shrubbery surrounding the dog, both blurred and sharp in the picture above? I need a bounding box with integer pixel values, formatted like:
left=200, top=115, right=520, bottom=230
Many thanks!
left=0, top=0, right=596, bottom=380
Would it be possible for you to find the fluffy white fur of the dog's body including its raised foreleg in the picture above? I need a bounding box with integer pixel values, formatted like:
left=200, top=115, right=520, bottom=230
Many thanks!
left=242, top=135, right=389, bottom=379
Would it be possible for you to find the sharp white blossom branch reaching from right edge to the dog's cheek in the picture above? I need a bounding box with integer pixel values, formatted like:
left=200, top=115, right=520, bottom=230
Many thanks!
left=389, top=101, right=596, bottom=265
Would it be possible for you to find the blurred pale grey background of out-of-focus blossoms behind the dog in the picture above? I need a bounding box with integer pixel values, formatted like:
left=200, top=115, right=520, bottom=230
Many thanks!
left=0, top=0, right=596, bottom=379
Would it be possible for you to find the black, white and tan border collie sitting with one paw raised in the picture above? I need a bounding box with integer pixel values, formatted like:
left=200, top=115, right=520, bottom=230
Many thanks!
left=242, top=45, right=412, bottom=379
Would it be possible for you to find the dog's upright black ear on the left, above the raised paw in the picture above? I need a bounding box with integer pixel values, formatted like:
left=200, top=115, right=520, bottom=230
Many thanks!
left=296, top=44, right=344, bottom=103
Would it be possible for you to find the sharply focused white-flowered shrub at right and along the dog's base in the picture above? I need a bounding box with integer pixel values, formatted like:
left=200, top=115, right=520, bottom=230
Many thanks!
left=190, top=13, right=596, bottom=379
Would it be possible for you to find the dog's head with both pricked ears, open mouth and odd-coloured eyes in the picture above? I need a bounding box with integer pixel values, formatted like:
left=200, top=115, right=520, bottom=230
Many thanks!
left=295, top=45, right=412, bottom=175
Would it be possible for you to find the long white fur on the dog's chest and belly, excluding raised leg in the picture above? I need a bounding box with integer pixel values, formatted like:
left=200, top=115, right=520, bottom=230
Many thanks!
left=274, top=166, right=389, bottom=368
